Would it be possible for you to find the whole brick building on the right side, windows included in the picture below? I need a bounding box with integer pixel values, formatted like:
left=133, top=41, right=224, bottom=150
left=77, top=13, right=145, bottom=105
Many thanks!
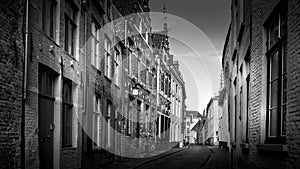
left=223, top=0, right=300, bottom=168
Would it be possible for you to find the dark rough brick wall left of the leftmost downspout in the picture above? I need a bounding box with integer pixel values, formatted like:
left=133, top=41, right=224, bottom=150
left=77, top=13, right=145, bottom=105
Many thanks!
left=0, top=0, right=24, bottom=168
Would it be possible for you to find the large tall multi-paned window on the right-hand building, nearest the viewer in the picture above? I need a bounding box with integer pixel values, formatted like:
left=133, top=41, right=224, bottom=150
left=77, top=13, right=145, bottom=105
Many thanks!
left=266, top=8, right=287, bottom=143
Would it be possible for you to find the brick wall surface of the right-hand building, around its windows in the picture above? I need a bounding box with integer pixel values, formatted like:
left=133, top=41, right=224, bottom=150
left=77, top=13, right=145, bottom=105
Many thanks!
left=223, top=0, right=300, bottom=168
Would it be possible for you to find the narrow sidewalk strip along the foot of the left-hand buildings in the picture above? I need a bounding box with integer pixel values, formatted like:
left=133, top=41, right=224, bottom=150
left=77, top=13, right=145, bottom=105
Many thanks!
left=103, top=147, right=188, bottom=169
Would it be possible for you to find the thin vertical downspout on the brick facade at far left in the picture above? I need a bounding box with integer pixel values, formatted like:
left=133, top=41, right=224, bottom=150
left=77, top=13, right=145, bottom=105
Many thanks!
left=21, top=0, right=29, bottom=169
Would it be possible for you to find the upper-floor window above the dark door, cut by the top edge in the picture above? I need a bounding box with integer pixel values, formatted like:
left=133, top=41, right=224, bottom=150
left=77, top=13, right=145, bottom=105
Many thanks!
left=42, top=0, right=57, bottom=39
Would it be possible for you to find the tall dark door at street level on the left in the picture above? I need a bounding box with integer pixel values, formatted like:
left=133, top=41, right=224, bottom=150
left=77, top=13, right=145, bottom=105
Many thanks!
left=38, top=68, right=54, bottom=169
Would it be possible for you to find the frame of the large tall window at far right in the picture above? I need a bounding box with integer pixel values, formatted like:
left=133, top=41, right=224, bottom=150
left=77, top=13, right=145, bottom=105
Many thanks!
left=265, top=8, right=287, bottom=144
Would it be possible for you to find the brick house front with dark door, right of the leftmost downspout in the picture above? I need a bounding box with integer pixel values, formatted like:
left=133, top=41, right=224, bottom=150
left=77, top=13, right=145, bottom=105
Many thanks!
left=25, top=0, right=85, bottom=168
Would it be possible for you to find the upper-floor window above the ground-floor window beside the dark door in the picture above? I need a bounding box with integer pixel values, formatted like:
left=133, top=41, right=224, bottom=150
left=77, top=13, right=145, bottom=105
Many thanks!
left=65, top=1, right=77, bottom=56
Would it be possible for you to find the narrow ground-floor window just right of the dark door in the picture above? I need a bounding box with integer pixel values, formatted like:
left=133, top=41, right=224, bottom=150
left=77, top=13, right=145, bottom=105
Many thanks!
left=62, top=79, right=73, bottom=147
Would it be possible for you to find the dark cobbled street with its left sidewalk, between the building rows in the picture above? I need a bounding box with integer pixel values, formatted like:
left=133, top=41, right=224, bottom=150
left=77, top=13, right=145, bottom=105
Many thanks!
left=105, top=146, right=230, bottom=169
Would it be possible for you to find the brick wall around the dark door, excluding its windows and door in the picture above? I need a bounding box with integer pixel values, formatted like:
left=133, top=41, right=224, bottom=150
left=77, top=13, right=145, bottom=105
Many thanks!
left=25, top=0, right=84, bottom=168
